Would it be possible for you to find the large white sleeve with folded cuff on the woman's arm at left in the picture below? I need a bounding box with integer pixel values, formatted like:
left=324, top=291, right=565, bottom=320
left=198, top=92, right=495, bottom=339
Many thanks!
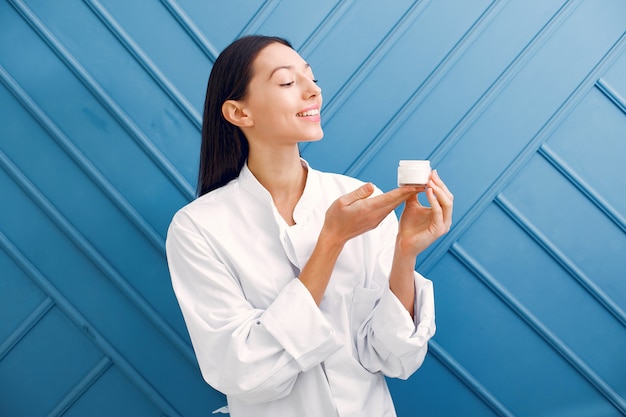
left=166, top=212, right=341, bottom=403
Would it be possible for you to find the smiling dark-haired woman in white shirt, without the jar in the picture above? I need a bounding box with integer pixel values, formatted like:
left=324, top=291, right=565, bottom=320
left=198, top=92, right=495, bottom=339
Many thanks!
left=167, top=36, right=453, bottom=417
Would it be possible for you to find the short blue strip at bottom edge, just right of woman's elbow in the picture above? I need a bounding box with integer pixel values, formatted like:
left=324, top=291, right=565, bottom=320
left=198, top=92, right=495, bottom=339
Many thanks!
left=428, top=340, right=515, bottom=417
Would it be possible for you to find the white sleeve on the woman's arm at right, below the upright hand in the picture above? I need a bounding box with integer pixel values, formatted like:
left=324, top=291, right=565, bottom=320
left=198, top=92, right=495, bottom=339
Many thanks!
left=355, top=213, right=436, bottom=379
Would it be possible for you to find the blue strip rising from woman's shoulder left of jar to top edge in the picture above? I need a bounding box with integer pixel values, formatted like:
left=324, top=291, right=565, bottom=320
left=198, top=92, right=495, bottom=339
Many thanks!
left=346, top=1, right=506, bottom=176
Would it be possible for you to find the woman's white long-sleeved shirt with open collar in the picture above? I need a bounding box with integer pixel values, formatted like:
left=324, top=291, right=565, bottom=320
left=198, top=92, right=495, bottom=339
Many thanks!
left=166, top=161, right=435, bottom=417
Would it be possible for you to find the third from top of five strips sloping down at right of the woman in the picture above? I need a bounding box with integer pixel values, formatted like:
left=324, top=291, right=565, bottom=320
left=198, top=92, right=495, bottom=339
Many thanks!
left=495, top=193, right=626, bottom=327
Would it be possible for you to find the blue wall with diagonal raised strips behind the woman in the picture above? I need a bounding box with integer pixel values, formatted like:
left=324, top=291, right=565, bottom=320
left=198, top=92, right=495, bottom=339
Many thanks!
left=0, top=0, right=626, bottom=417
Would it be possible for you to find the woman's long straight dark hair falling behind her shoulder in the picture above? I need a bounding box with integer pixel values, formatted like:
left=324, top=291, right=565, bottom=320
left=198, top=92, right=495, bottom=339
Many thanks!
left=197, top=35, right=292, bottom=196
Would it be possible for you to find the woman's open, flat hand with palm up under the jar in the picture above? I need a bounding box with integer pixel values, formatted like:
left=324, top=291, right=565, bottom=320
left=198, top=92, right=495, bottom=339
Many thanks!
left=322, top=183, right=419, bottom=245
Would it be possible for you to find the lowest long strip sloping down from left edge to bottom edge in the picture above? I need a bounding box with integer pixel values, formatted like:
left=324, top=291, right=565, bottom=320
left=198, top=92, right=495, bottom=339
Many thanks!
left=0, top=229, right=181, bottom=417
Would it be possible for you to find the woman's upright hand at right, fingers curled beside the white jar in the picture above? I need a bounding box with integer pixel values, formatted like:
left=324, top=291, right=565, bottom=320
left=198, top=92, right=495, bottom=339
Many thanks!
left=396, top=170, right=454, bottom=256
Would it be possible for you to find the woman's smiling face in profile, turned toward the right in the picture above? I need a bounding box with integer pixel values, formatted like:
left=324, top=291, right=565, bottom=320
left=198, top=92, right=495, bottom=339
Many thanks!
left=234, top=43, right=324, bottom=145
